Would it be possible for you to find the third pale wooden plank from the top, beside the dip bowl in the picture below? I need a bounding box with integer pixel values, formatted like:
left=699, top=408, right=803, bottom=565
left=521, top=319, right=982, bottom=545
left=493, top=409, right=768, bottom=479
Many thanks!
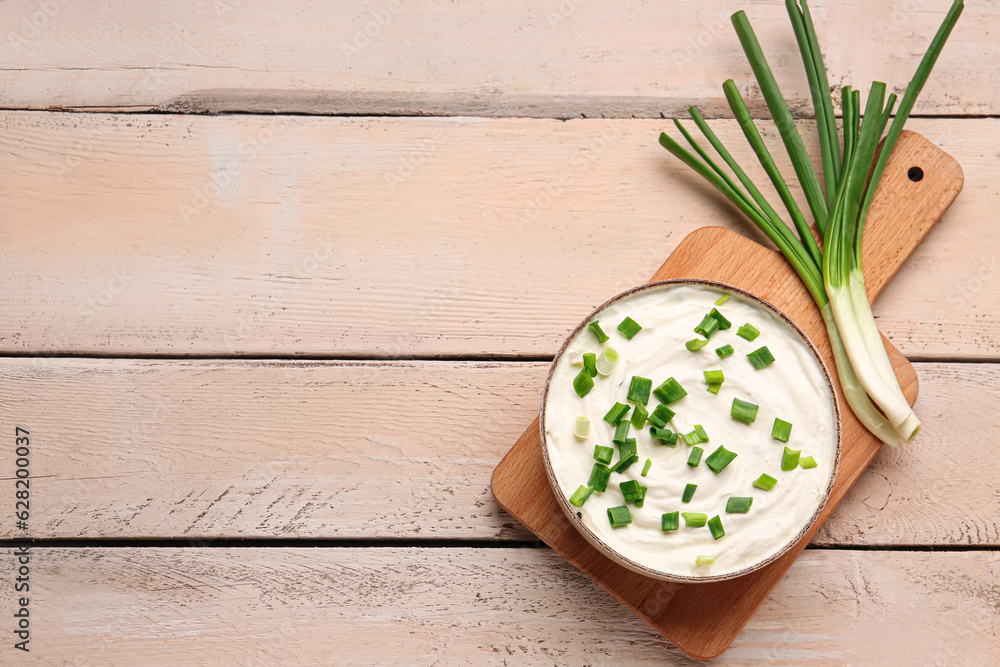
left=0, top=358, right=1000, bottom=545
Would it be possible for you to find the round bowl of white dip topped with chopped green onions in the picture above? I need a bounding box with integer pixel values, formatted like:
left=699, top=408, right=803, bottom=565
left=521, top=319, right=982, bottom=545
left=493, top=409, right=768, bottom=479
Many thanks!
left=540, top=280, right=841, bottom=582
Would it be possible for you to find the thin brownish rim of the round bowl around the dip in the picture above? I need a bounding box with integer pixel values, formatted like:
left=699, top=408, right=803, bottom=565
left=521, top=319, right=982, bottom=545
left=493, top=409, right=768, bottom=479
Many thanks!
left=538, top=278, right=843, bottom=584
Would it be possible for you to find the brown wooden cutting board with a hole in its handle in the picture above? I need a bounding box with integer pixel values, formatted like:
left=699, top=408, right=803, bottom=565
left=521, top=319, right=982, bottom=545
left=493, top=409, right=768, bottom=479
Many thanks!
left=492, top=132, right=963, bottom=659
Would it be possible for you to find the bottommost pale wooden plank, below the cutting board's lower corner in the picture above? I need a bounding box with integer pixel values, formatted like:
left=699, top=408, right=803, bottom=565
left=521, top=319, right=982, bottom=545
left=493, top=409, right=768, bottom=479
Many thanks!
left=0, top=548, right=1000, bottom=666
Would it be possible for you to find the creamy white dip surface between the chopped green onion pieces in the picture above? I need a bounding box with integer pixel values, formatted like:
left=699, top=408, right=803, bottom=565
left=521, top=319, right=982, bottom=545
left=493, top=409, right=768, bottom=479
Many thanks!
left=544, top=285, right=837, bottom=577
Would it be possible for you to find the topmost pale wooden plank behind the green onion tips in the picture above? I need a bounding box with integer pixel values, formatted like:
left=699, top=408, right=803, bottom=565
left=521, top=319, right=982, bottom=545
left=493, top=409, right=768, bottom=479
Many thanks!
left=0, top=0, right=1000, bottom=118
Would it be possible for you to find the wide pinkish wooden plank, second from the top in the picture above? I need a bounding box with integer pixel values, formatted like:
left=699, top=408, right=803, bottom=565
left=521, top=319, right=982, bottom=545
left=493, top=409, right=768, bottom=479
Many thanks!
left=0, top=113, right=988, bottom=359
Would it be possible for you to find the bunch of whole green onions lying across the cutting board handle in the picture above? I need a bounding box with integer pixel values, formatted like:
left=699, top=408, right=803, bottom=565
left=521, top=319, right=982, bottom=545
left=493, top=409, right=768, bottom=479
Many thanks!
left=660, top=0, right=964, bottom=445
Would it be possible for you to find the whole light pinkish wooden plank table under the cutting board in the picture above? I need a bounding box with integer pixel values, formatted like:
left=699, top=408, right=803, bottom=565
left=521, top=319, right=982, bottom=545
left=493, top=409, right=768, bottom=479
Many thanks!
left=0, top=0, right=1000, bottom=665
